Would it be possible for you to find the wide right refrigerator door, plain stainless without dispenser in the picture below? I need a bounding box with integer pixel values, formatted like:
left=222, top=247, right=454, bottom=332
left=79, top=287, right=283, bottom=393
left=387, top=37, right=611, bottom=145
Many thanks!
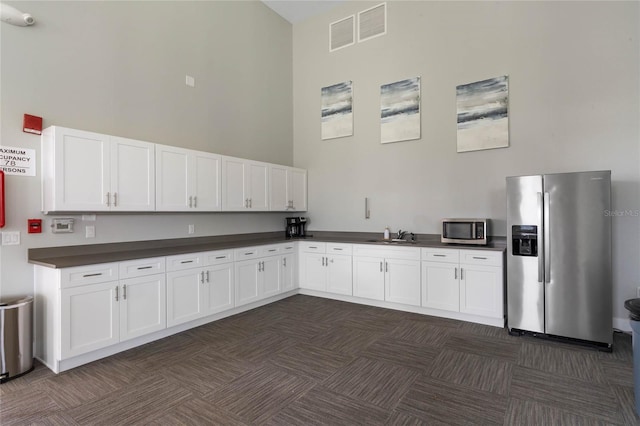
left=543, top=171, right=613, bottom=344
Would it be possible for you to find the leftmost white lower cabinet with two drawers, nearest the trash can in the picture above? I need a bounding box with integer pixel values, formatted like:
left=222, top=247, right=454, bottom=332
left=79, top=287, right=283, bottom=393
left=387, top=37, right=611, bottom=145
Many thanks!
left=60, top=258, right=166, bottom=359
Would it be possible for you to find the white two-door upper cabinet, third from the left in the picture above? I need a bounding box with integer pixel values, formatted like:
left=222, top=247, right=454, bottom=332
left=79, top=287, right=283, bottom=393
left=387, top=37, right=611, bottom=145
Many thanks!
left=222, top=157, right=269, bottom=211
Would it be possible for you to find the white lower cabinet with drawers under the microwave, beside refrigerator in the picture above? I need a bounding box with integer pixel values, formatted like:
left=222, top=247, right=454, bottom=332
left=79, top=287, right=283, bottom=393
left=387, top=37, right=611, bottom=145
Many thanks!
left=422, top=248, right=504, bottom=318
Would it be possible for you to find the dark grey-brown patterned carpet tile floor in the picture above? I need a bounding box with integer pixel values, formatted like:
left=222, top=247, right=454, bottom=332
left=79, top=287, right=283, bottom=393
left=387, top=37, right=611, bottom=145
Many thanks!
left=0, top=296, right=640, bottom=425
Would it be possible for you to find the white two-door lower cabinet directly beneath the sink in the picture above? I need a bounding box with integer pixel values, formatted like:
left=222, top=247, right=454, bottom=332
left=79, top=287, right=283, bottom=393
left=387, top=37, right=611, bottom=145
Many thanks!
left=353, top=245, right=420, bottom=306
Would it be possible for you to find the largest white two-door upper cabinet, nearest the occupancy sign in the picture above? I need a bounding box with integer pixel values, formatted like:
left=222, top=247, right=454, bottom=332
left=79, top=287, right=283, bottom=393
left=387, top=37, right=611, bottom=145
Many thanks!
left=42, top=126, right=155, bottom=212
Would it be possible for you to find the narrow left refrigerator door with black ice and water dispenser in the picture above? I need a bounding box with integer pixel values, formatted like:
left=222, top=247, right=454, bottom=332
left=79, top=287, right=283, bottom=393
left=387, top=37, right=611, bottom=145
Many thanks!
left=507, top=175, right=544, bottom=333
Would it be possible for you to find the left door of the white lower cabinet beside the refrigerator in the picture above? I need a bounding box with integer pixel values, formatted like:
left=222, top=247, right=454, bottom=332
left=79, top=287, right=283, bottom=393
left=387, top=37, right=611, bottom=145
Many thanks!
left=422, top=262, right=460, bottom=312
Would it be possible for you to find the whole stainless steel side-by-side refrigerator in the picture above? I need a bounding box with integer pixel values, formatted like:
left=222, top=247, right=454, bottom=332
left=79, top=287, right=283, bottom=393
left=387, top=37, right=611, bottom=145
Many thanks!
left=507, top=171, right=613, bottom=350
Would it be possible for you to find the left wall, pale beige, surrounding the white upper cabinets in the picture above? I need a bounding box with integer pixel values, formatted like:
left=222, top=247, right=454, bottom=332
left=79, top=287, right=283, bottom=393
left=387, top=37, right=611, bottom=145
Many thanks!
left=0, top=1, right=293, bottom=297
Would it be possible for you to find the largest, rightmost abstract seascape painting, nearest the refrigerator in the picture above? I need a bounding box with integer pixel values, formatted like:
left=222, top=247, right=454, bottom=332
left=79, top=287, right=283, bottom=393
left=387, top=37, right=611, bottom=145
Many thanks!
left=456, top=76, right=509, bottom=152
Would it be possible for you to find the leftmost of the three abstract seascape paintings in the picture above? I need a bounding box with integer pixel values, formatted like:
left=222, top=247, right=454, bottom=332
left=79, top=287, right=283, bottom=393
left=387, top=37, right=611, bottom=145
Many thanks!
left=320, top=81, right=353, bottom=140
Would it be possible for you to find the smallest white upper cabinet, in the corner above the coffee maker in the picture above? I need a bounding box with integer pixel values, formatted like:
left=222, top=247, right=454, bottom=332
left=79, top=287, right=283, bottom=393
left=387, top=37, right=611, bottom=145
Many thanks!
left=269, top=165, right=307, bottom=211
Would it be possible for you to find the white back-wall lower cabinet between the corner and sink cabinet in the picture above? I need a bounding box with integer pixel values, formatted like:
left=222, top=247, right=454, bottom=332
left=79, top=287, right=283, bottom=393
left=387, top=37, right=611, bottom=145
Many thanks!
left=300, top=242, right=353, bottom=296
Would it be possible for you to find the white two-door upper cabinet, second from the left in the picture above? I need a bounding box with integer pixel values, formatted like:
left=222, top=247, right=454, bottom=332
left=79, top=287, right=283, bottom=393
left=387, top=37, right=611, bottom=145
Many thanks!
left=156, top=145, right=221, bottom=211
